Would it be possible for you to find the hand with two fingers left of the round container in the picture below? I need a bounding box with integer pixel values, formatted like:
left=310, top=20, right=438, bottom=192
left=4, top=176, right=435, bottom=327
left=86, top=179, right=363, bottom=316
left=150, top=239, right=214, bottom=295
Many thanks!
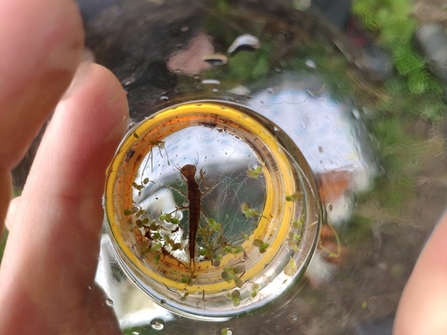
left=0, top=0, right=128, bottom=334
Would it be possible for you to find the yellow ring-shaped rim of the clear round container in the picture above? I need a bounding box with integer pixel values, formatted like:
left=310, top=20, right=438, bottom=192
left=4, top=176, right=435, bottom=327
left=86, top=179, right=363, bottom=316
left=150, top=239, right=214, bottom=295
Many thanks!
left=105, top=102, right=297, bottom=293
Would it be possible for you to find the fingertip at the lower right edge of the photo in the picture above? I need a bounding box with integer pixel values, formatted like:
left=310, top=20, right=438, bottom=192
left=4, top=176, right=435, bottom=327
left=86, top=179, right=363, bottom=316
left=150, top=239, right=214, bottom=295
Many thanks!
left=394, top=213, right=447, bottom=335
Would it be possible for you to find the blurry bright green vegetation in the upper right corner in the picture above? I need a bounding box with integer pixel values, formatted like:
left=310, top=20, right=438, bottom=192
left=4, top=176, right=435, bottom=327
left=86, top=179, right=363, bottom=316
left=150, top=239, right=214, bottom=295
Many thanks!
left=353, top=0, right=446, bottom=211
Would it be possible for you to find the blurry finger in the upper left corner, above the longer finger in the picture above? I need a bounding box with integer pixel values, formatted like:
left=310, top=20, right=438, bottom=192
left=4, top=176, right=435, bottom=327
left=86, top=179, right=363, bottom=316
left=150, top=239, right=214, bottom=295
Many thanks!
left=0, top=0, right=84, bottom=228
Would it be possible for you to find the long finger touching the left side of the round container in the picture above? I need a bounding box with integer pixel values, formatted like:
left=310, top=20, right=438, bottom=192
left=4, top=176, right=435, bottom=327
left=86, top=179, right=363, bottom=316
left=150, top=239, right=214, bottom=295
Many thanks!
left=0, top=65, right=128, bottom=333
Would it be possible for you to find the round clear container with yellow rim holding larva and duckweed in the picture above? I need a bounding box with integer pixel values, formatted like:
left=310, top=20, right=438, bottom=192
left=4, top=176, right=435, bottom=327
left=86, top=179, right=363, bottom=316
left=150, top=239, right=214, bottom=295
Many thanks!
left=105, top=100, right=324, bottom=320
